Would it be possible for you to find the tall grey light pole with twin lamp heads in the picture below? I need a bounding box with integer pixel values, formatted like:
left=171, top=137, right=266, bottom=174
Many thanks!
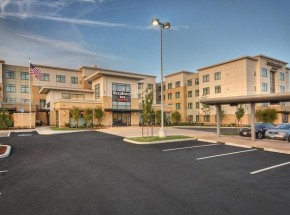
left=151, top=18, right=170, bottom=137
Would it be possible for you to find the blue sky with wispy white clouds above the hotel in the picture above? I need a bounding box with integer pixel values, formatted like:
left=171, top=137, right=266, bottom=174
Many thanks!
left=0, top=0, right=290, bottom=76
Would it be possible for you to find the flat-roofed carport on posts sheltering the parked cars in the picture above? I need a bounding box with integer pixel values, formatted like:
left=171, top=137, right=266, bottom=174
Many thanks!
left=200, top=92, right=290, bottom=141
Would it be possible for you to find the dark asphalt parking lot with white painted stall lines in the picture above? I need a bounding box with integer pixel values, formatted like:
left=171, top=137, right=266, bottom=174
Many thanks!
left=0, top=131, right=290, bottom=215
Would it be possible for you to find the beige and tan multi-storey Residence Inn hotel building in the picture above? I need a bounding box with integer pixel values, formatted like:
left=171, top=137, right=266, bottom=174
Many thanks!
left=0, top=55, right=290, bottom=127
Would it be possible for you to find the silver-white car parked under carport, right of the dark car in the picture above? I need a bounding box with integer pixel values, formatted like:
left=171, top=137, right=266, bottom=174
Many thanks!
left=265, top=123, right=290, bottom=142
